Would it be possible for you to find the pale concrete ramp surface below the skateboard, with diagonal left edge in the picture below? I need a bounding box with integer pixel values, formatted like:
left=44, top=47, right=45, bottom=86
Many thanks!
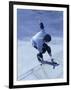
left=18, top=61, right=62, bottom=80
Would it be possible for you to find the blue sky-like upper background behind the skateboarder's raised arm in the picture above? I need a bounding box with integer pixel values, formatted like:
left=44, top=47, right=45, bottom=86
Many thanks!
left=17, top=9, right=63, bottom=40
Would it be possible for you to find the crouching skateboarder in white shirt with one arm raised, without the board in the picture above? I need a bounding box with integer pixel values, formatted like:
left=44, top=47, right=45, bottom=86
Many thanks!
left=32, top=22, right=53, bottom=63
